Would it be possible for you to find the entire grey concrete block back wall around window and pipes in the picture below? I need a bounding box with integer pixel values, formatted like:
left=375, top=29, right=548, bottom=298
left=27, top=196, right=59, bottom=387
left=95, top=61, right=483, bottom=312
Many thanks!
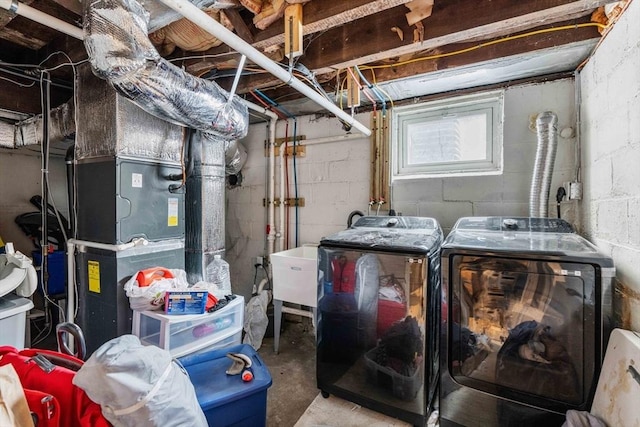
left=226, top=79, right=576, bottom=296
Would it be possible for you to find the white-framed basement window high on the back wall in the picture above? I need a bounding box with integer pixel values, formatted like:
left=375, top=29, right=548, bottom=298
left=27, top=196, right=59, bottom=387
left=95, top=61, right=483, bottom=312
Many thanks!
left=392, top=91, right=503, bottom=180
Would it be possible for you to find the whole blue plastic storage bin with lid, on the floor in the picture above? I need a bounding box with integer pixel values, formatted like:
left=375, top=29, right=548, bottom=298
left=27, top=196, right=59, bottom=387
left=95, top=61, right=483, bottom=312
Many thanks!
left=179, top=344, right=271, bottom=427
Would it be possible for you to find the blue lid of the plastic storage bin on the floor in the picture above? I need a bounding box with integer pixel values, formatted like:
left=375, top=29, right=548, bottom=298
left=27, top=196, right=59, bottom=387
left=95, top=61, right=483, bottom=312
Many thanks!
left=178, top=344, right=272, bottom=411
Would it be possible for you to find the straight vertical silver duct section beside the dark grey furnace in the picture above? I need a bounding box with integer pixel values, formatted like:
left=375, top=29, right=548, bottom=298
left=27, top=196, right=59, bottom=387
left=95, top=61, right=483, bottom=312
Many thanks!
left=185, top=132, right=225, bottom=283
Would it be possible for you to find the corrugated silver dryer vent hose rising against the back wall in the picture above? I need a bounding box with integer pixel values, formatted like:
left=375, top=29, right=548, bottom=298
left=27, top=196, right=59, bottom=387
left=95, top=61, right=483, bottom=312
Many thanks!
left=529, top=111, right=558, bottom=218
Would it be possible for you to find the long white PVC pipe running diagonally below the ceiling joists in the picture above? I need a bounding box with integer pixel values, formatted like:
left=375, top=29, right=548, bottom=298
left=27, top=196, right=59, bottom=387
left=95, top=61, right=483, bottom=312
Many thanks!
left=157, top=0, right=371, bottom=136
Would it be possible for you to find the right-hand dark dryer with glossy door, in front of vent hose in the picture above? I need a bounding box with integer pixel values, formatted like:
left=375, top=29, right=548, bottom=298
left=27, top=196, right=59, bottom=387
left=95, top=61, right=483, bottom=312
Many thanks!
left=439, top=217, right=615, bottom=427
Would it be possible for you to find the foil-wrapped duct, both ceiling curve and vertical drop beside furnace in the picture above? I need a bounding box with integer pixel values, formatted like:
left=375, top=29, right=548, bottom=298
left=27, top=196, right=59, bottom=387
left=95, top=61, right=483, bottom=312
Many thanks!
left=84, top=0, right=249, bottom=283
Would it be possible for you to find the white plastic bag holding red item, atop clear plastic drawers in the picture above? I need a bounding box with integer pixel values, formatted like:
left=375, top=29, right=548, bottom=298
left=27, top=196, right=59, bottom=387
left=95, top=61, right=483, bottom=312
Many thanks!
left=124, top=269, right=189, bottom=311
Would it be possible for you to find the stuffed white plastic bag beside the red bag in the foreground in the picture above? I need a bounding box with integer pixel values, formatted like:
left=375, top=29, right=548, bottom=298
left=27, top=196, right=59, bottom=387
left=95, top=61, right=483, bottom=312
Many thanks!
left=73, top=335, right=207, bottom=427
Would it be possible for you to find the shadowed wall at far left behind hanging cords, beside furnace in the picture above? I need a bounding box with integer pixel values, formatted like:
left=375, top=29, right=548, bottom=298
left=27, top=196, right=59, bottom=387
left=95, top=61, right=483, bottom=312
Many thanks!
left=0, top=151, right=69, bottom=256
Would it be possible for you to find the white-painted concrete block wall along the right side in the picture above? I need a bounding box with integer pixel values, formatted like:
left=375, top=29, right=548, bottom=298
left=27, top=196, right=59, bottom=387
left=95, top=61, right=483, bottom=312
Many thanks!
left=578, top=1, right=640, bottom=331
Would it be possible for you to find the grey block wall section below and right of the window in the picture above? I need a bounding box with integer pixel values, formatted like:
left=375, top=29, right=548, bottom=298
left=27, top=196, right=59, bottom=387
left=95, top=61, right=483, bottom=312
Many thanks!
left=393, top=79, right=577, bottom=233
